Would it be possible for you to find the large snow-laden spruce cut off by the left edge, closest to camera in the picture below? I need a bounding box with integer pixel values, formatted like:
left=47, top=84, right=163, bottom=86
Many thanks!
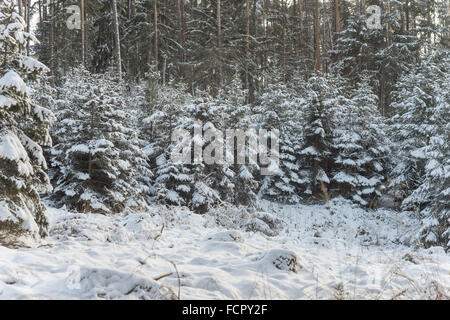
left=0, top=0, right=53, bottom=236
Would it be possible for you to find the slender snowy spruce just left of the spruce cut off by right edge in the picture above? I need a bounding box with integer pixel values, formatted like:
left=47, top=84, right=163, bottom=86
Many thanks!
left=390, top=51, right=448, bottom=209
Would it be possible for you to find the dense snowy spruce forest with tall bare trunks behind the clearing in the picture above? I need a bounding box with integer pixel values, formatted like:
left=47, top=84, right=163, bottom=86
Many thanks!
left=0, top=0, right=450, bottom=252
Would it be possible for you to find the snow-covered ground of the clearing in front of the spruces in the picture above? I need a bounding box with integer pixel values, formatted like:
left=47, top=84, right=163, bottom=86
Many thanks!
left=0, top=200, right=450, bottom=300
